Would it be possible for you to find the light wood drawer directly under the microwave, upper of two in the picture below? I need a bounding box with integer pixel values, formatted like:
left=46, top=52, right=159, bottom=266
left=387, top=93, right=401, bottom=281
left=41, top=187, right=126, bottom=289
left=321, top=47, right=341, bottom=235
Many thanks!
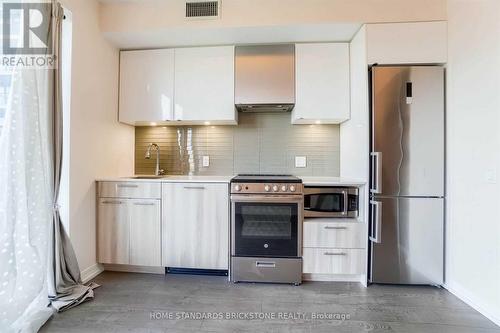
left=303, top=222, right=367, bottom=249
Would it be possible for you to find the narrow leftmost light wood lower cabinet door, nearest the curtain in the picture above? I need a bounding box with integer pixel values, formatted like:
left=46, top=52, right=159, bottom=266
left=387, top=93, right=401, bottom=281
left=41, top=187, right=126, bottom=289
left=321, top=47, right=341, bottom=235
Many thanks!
left=97, top=199, right=130, bottom=264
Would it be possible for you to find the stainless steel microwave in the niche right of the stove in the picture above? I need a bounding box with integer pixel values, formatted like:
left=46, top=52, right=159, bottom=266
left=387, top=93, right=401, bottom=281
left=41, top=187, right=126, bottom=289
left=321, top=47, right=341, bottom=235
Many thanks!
left=304, top=187, right=359, bottom=218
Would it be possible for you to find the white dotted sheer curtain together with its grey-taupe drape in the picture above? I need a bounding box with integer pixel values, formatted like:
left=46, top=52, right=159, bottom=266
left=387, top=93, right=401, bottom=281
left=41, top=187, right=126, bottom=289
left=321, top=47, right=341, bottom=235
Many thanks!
left=0, top=1, right=94, bottom=332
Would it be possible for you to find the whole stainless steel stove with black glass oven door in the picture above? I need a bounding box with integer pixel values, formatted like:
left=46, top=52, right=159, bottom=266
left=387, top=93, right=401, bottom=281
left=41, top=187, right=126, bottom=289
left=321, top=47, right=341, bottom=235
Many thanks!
left=230, top=175, right=304, bottom=285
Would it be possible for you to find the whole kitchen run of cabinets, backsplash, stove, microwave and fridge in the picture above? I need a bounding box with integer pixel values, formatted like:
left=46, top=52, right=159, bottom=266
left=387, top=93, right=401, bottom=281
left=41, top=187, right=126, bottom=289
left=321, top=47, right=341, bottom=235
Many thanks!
left=97, top=22, right=446, bottom=286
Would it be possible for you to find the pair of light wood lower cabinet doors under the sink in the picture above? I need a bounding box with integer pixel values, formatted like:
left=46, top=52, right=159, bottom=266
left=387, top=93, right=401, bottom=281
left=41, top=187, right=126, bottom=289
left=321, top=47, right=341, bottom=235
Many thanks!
left=97, top=198, right=161, bottom=266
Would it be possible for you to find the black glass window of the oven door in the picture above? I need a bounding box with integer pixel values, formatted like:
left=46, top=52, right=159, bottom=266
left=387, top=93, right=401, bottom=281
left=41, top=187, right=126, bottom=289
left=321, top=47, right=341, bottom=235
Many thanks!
left=234, top=202, right=298, bottom=257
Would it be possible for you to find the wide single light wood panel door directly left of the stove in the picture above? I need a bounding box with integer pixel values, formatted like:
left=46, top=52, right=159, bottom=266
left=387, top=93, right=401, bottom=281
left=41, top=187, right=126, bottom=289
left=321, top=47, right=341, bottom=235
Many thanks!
left=162, top=183, right=229, bottom=269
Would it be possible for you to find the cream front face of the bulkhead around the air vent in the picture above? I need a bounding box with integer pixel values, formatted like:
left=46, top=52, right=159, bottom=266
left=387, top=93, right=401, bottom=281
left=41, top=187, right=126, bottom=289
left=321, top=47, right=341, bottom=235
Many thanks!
left=101, top=0, right=446, bottom=32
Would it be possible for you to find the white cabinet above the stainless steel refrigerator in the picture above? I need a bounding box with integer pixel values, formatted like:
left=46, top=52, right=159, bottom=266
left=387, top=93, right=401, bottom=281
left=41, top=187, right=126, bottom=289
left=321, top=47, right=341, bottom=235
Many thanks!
left=366, top=21, right=447, bottom=65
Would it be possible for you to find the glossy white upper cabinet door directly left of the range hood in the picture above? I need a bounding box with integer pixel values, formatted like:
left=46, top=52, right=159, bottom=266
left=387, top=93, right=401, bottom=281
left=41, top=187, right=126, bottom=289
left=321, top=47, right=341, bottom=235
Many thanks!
left=174, top=46, right=237, bottom=124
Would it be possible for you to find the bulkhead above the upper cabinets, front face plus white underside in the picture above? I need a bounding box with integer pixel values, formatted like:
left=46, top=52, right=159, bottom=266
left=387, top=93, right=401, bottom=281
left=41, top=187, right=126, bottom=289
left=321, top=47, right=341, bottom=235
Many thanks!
left=97, top=0, right=446, bottom=49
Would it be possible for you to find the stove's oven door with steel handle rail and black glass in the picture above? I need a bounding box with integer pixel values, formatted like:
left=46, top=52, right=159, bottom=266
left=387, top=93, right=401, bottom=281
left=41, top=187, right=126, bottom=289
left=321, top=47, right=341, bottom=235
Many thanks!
left=231, top=195, right=304, bottom=258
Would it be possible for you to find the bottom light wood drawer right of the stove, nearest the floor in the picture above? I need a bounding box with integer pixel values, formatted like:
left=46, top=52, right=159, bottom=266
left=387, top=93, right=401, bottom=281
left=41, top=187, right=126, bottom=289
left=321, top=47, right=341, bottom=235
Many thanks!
left=302, top=248, right=366, bottom=274
